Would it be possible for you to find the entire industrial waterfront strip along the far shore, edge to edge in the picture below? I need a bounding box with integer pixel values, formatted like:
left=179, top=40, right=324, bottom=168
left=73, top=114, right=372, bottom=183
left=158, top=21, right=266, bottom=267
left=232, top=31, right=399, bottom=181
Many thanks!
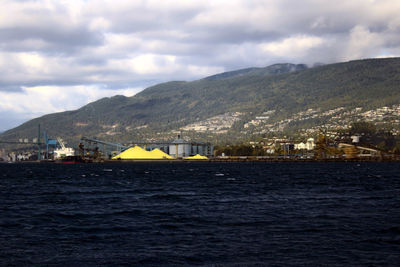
left=0, top=125, right=400, bottom=163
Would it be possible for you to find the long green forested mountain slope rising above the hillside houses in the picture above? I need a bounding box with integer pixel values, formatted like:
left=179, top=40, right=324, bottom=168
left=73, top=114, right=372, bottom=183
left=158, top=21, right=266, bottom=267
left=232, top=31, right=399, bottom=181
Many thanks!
left=0, top=58, right=400, bottom=146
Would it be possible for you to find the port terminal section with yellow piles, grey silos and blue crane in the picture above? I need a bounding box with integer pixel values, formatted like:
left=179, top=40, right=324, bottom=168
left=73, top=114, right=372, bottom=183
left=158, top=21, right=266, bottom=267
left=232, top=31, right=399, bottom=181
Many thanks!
left=0, top=125, right=214, bottom=162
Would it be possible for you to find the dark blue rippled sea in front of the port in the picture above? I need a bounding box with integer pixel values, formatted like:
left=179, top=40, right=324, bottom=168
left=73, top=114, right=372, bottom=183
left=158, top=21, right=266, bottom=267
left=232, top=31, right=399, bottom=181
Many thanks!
left=0, top=162, right=400, bottom=266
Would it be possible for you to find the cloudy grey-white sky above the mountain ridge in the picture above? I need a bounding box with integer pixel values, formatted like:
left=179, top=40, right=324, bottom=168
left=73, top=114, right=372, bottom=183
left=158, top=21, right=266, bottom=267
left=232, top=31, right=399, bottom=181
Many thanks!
left=0, top=0, right=400, bottom=131
